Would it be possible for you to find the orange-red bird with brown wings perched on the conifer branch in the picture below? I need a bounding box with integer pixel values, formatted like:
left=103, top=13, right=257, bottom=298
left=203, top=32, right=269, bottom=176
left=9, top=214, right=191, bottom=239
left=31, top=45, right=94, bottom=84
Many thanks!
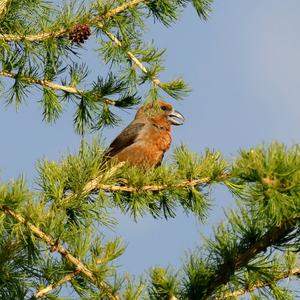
left=107, top=100, right=185, bottom=169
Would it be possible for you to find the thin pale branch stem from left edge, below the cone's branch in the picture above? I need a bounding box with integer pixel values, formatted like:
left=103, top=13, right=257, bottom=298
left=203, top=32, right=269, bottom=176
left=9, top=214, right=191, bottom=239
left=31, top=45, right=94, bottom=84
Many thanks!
left=0, top=70, right=115, bottom=105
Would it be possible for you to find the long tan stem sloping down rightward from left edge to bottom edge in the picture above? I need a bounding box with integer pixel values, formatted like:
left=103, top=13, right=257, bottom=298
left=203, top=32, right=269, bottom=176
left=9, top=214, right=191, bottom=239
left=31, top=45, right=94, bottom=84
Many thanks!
left=0, top=205, right=119, bottom=300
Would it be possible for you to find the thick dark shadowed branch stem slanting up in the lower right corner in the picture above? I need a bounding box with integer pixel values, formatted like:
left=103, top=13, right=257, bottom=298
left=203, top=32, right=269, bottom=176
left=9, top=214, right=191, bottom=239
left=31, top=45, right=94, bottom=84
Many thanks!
left=205, top=214, right=300, bottom=296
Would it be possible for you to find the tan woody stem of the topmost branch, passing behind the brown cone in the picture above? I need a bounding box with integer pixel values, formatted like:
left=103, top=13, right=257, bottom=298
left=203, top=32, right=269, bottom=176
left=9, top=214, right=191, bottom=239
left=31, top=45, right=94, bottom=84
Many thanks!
left=0, top=0, right=146, bottom=42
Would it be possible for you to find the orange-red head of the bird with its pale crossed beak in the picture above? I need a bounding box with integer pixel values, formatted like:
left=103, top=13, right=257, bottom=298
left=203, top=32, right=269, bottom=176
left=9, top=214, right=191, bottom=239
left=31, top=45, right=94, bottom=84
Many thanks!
left=135, top=100, right=185, bottom=126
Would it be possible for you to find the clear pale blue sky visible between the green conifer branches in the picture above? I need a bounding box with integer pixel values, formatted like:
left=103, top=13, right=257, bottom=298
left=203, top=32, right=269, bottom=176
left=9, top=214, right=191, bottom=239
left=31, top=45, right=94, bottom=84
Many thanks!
left=0, top=0, right=300, bottom=286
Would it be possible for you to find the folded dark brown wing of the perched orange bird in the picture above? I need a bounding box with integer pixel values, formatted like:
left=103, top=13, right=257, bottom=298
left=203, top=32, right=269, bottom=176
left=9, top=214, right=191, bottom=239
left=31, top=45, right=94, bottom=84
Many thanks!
left=107, top=123, right=145, bottom=157
